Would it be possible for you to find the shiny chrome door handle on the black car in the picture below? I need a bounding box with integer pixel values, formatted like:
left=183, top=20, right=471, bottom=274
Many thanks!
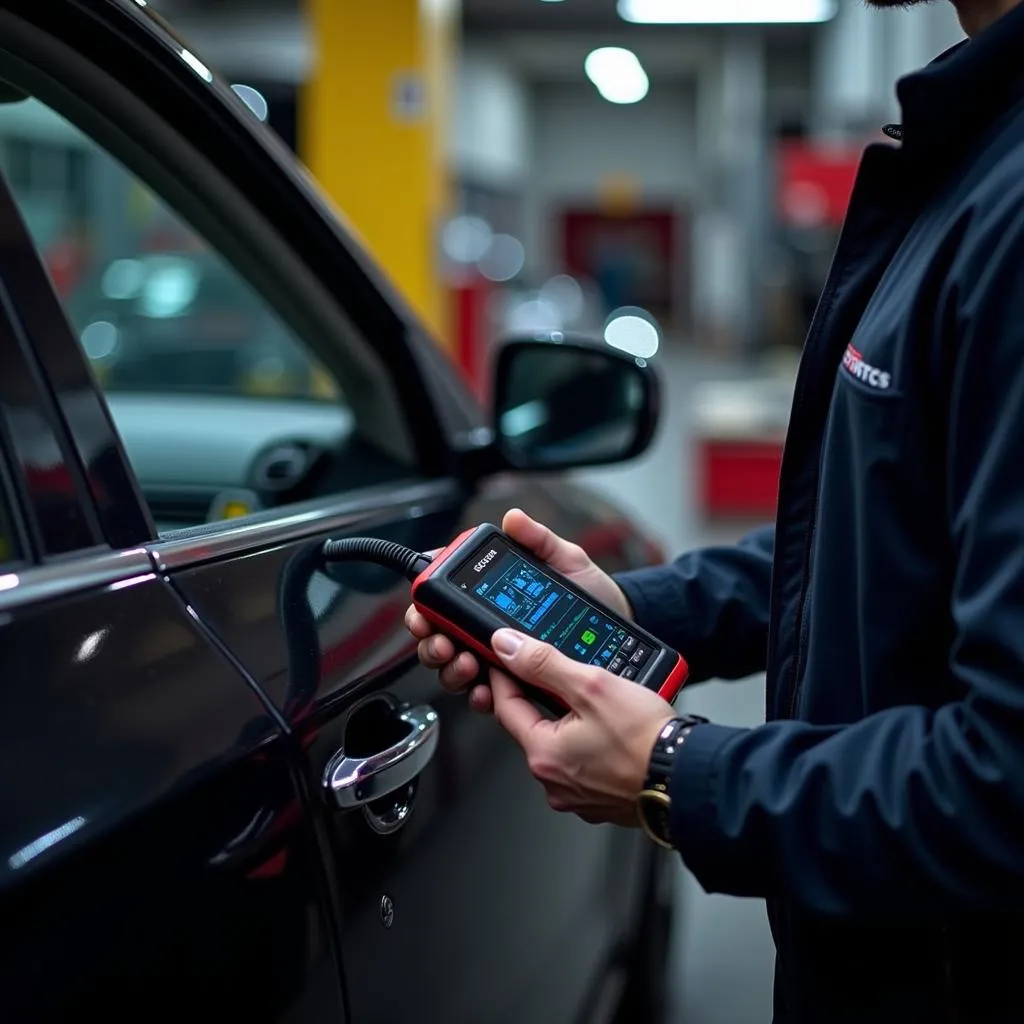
left=324, top=705, right=440, bottom=808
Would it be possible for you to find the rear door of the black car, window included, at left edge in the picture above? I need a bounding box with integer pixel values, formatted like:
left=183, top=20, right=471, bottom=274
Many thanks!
left=0, top=181, right=343, bottom=1024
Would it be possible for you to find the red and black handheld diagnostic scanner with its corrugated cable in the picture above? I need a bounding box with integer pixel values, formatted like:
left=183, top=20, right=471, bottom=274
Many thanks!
left=324, top=523, right=689, bottom=714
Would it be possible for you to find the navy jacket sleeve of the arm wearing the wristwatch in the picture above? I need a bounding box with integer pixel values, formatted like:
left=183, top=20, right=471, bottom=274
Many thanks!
left=672, top=207, right=1024, bottom=921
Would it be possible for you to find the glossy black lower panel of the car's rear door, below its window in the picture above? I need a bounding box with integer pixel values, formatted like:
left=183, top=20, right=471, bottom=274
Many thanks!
left=0, top=552, right=342, bottom=1024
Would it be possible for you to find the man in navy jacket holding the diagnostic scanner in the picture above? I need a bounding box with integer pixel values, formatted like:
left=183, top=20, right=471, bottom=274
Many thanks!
left=408, top=0, right=1024, bottom=1024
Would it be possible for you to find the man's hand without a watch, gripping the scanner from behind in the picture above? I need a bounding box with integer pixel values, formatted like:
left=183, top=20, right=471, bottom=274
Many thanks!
left=406, top=509, right=633, bottom=712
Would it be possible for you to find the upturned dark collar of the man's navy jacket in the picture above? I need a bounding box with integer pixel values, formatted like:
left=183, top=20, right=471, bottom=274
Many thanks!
left=888, top=2, right=1024, bottom=163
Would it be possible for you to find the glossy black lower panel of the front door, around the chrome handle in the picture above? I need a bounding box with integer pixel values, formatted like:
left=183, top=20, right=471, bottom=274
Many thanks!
left=158, top=483, right=641, bottom=1024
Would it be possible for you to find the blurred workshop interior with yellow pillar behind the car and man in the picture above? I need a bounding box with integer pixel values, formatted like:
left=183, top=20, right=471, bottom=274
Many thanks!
left=0, top=0, right=961, bottom=1024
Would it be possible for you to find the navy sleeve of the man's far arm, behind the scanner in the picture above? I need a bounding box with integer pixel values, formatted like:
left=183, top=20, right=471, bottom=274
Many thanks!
left=615, top=526, right=775, bottom=682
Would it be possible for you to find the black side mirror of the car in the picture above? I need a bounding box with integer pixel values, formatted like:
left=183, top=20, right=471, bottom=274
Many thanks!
left=493, top=332, right=660, bottom=471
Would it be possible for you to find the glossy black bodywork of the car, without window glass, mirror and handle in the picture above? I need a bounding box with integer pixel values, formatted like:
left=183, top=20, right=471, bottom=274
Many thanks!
left=0, top=0, right=671, bottom=1024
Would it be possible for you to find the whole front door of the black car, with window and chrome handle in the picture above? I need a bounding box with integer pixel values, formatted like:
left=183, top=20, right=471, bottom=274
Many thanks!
left=0, top=4, right=646, bottom=1022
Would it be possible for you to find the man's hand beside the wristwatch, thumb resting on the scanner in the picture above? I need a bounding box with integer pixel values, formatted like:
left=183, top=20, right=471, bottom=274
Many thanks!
left=490, top=630, right=676, bottom=825
